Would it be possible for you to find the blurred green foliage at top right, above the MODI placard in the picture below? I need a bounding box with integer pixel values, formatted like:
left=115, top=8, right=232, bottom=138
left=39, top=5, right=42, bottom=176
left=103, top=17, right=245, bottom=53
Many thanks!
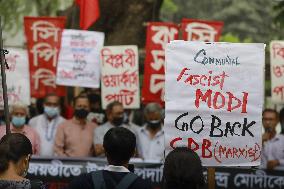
left=161, top=0, right=284, bottom=44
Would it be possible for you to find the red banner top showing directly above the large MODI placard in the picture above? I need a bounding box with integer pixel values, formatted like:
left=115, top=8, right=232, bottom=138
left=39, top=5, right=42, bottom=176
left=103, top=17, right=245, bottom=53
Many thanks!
left=181, top=18, right=224, bottom=42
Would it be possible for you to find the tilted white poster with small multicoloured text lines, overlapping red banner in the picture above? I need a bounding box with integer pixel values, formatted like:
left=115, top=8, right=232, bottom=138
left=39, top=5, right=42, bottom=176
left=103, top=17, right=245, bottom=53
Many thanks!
left=56, top=30, right=104, bottom=88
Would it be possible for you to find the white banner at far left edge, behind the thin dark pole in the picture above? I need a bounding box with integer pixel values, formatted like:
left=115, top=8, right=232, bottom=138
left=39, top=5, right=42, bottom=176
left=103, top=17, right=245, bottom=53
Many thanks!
left=0, top=48, right=31, bottom=108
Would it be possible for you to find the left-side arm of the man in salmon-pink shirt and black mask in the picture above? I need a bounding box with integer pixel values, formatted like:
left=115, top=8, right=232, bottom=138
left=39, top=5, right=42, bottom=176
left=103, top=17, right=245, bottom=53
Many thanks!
left=53, top=125, right=67, bottom=156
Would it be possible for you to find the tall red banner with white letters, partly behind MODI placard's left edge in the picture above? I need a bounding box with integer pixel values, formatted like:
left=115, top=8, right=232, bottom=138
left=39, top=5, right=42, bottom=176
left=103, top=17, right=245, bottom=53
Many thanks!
left=142, top=22, right=178, bottom=105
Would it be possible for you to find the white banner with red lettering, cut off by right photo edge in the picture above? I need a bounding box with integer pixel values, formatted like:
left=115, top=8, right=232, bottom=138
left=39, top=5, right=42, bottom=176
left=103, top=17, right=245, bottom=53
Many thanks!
left=270, top=41, right=284, bottom=104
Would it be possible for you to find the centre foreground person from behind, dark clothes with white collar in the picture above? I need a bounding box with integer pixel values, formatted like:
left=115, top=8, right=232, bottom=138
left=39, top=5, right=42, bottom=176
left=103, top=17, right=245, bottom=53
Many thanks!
left=69, top=127, right=151, bottom=189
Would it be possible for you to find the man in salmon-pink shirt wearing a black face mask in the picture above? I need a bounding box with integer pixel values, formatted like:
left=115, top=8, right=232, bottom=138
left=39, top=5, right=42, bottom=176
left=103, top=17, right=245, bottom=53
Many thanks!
left=54, top=95, right=97, bottom=157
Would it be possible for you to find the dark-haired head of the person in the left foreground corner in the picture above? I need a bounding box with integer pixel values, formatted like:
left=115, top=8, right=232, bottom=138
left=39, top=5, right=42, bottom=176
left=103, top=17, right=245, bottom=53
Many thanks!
left=0, top=133, right=32, bottom=180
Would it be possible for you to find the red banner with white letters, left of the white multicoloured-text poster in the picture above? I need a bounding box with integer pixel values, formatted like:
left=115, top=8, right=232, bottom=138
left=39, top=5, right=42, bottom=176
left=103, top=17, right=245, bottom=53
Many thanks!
left=24, top=17, right=66, bottom=98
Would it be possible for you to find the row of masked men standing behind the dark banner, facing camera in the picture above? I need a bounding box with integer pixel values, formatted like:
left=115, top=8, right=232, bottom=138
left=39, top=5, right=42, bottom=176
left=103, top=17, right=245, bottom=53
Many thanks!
left=0, top=93, right=164, bottom=162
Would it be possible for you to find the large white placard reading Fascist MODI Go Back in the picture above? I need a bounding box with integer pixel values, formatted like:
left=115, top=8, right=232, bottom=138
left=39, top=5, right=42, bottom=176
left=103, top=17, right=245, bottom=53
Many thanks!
left=164, top=41, right=264, bottom=166
